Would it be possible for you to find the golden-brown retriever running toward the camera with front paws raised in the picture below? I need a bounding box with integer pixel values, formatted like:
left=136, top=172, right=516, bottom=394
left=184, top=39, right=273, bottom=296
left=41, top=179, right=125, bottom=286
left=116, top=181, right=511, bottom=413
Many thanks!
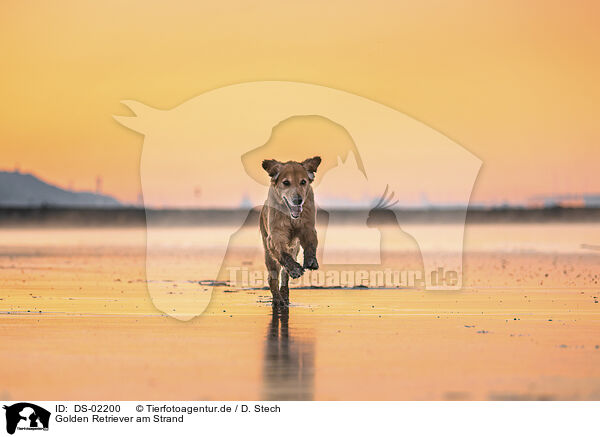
left=260, top=156, right=321, bottom=306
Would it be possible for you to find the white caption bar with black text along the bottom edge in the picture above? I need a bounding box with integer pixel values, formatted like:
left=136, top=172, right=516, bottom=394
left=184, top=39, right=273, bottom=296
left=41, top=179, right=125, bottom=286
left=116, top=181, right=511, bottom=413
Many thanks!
left=0, top=401, right=600, bottom=437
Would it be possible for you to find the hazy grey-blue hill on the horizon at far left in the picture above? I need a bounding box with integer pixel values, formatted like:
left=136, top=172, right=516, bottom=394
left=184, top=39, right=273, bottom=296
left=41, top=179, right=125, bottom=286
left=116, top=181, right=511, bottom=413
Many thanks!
left=0, top=171, right=121, bottom=208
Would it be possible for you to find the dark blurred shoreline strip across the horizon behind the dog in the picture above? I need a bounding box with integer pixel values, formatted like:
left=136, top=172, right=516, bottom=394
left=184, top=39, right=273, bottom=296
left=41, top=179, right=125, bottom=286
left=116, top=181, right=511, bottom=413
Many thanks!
left=0, top=207, right=600, bottom=228
